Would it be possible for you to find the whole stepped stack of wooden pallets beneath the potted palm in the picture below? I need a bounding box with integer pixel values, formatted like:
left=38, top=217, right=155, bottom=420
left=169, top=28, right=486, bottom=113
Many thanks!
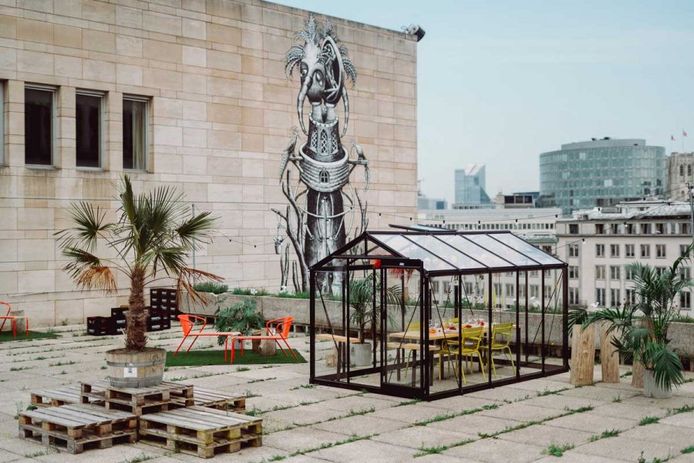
left=19, top=381, right=262, bottom=458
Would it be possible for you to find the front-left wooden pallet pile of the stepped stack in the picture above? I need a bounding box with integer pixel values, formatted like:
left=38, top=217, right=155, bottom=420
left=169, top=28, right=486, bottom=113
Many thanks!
left=19, top=404, right=137, bottom=454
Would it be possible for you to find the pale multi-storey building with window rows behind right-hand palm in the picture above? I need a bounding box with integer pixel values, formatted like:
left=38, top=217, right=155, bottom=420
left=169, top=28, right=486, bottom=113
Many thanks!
left=556, top=201, right=692, bottom=310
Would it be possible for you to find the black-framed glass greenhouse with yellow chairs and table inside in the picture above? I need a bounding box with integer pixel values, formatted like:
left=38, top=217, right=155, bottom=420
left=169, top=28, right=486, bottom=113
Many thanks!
left=310, top=229, right=569, bottom=400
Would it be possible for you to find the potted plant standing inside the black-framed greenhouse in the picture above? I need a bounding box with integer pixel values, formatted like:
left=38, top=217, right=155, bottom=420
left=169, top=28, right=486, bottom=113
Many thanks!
left=349, top=272, right=402, bottom=366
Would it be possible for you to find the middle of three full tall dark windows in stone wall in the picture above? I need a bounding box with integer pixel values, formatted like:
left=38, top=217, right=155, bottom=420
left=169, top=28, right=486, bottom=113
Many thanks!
left=75, top=90, right=103, bottom=167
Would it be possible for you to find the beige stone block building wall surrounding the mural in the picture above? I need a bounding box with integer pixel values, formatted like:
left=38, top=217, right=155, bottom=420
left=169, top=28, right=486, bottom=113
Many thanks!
left=0, top=0, right=417, bottom=325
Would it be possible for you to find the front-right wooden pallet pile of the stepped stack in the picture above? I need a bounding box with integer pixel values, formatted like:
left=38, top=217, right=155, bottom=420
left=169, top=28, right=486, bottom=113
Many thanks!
left=139, top=406, right=263, bottom=458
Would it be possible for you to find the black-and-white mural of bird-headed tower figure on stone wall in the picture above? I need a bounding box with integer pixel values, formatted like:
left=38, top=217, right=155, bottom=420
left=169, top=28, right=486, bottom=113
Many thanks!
left=273, top=16, right=369, bottom=292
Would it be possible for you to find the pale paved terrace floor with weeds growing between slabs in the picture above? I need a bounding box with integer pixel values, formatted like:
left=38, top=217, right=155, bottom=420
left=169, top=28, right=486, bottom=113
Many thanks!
left=0, top=326, right=694, bottom=463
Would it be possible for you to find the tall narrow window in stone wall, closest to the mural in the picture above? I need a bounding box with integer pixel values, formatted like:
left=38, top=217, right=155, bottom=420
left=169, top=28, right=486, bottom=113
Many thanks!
left=123, top=96, right=148, bottom=170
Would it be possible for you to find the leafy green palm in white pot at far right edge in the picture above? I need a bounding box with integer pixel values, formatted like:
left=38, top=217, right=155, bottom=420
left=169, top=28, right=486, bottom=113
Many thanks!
left=584, top=243, right=694, bottom=398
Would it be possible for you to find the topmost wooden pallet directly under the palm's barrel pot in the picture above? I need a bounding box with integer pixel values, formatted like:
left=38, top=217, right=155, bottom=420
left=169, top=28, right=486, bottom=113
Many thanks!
left=80, top=382, right=193, bottom=416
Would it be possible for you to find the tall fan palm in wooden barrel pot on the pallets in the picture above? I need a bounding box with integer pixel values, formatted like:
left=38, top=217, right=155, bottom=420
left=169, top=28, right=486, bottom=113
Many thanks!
left=57, top=175, right=220, bottom=387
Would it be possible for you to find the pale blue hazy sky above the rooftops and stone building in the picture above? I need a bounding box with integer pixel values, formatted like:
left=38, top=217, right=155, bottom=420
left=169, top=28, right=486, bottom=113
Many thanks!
left=279, top=0, right=694, bottom=203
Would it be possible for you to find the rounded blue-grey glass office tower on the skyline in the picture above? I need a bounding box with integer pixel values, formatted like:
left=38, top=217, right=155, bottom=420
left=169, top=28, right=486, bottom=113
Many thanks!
left=540, top=137, right=667, bottom=214
